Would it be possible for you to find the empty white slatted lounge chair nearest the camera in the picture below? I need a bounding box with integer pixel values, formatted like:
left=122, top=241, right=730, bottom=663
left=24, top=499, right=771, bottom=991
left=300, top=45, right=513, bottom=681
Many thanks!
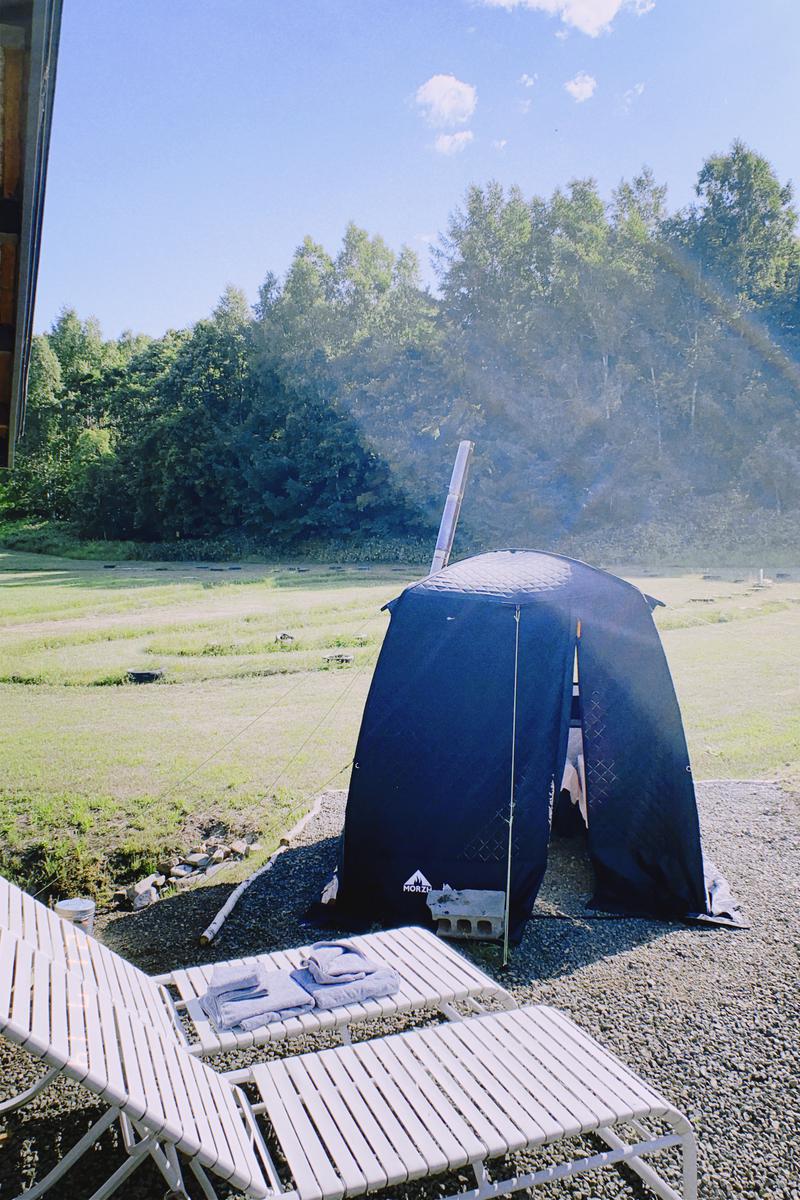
left=0, top=931, right=697, bottom=1200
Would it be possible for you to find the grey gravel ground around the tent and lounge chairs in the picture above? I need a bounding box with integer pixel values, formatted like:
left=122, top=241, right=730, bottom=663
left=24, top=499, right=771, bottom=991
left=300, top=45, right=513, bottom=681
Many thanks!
left=0, top=782, right=800, bottom=1200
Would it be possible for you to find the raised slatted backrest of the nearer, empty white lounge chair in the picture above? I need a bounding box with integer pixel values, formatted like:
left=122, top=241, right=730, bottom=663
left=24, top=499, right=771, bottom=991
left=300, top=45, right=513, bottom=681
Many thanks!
left=0, top=930, right=271, bottom=1200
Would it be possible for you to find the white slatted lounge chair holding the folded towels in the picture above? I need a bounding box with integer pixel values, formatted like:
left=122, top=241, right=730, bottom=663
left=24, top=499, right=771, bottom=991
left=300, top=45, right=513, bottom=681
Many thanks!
left=0, top=876, right=516, bottom=1075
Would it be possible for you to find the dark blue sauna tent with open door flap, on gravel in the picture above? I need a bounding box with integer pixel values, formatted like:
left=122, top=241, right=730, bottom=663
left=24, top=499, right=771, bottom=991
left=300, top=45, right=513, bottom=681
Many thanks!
left=336, top=550, right=709, bottom=936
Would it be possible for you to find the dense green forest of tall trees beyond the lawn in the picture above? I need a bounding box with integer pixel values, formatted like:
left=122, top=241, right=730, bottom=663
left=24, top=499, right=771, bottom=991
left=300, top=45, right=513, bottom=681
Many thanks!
left=0, top=143, right=800, bottom=564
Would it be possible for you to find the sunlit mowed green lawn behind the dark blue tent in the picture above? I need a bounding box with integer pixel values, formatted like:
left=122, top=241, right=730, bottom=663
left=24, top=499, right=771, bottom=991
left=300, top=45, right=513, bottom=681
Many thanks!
left=0, top=552, right=800, bottom=890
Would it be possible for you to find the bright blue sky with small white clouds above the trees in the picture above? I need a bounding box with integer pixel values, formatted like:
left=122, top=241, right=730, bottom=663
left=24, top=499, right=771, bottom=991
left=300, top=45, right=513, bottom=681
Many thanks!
left=36, top=0, right=800, bottom=335
